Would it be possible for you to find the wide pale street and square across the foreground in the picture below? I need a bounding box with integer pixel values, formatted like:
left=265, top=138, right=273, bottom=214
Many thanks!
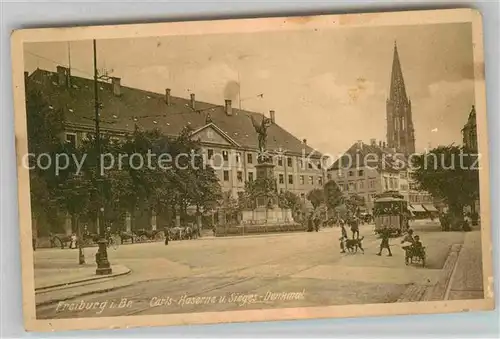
left=35, top=225, right=481, bottom=318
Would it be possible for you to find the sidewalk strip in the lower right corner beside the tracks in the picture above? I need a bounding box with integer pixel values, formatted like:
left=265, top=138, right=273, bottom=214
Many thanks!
left=445, top=230, right=484, bottom=300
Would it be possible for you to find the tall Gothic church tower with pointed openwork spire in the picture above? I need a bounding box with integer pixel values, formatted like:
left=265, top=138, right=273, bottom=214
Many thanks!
left=386, top=42, right=415, bottom=155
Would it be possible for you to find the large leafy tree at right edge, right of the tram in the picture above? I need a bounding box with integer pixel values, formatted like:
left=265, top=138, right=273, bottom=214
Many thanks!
left=412, top=145, right=479, bottom=227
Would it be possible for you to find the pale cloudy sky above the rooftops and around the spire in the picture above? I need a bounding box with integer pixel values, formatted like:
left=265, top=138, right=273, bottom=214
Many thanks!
left=25, top=23, right=474, bottom=156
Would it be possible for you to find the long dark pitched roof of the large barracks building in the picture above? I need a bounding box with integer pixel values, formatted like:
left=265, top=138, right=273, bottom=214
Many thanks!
left=28, top=69, right=321, bottom=157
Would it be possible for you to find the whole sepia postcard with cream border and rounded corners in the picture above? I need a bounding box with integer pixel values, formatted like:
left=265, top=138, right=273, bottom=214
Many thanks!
left=12, top=9, right=495, bottom=331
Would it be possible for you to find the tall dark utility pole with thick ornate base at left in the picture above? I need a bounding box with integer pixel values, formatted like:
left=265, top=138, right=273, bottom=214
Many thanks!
left=93, top=39, right=112, bottom=275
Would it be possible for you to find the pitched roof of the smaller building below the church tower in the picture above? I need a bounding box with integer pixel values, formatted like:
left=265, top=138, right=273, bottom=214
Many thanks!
left=328, top=141, right=408, bottom=171
